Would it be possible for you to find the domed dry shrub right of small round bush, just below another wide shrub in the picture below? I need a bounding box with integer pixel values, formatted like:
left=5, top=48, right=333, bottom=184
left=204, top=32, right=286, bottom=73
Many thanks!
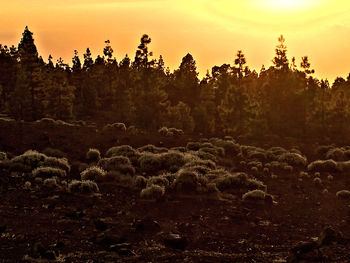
left=97, top=156, right=135, bottom=175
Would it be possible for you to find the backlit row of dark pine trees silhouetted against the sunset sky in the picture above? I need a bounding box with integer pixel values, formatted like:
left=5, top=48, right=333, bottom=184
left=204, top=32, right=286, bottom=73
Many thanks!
left=0, top=27, right=350, bottom=141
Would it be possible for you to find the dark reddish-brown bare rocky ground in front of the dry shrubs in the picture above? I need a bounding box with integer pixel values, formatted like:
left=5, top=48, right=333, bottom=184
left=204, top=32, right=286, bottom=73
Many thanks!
left=0, top=120, right=350, bottom=263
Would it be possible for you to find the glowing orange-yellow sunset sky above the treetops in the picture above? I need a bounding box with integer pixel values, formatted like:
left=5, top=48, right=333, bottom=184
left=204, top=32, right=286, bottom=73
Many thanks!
left=0, top=0, right=350, bottom=81
